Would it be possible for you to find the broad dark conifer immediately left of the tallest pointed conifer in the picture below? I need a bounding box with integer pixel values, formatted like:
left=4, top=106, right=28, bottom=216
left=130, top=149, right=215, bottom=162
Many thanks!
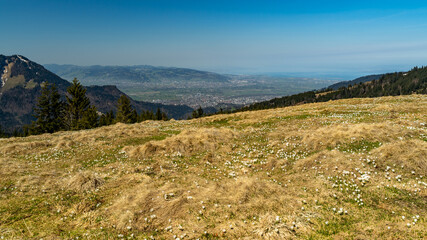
left=30, top=83, right=64, bottom=134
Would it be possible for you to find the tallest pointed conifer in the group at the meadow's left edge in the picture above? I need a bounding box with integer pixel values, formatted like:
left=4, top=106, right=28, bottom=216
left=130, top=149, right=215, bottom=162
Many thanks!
left=66, top=78, right=90, bottom=130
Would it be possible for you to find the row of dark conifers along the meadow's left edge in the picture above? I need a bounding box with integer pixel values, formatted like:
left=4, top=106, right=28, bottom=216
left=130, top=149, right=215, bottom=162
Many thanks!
left=0, top=78, right=168, bottom=137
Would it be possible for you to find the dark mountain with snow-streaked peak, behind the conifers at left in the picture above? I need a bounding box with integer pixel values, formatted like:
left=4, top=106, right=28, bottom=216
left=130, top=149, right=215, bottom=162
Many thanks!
left=0, top=55, right=193, bottom=130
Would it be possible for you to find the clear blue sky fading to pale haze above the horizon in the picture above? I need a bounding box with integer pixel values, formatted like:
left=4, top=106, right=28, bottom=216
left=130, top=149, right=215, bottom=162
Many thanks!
left=0, top=0, right=427, bottom=77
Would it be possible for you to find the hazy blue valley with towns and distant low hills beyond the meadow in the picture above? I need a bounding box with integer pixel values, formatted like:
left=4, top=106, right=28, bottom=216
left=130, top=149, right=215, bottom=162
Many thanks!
left=45, top=64, right=339, bottom=108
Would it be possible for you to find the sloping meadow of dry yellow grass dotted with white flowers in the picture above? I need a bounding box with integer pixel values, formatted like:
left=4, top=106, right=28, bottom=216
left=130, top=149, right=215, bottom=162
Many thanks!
left=0, top=95, right=427, bottom=239
